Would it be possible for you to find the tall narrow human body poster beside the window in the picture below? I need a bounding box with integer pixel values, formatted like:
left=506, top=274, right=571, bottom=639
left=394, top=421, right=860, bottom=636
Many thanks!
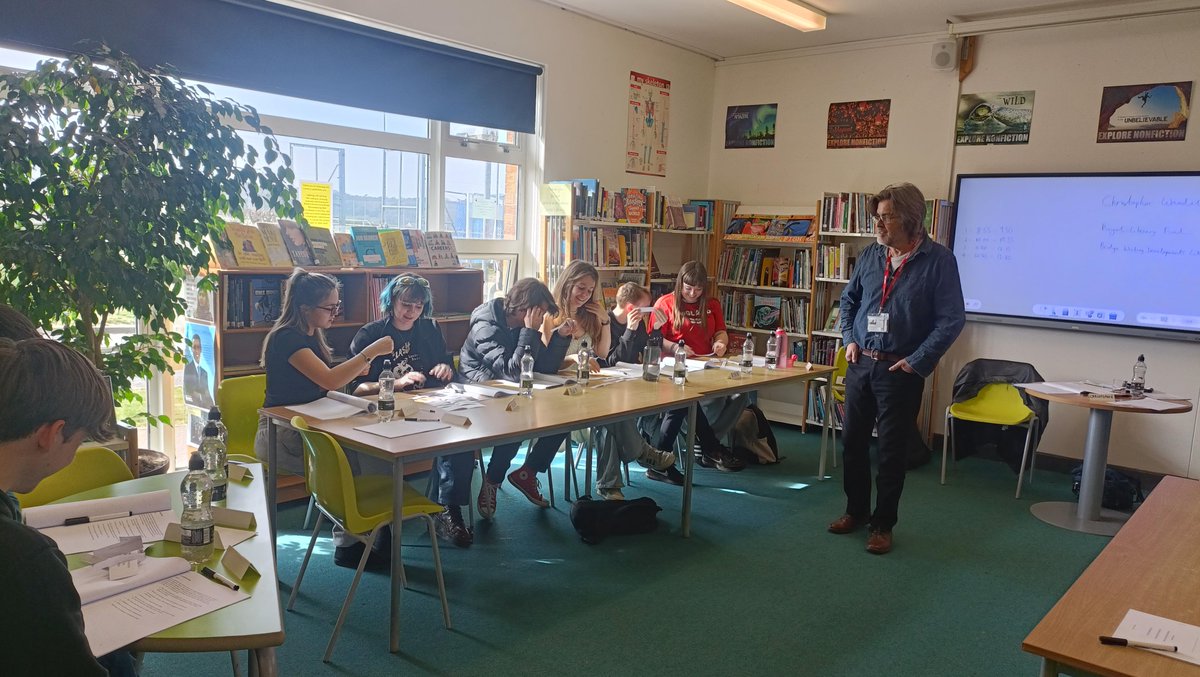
left=625, top=71, right=671, bottom=176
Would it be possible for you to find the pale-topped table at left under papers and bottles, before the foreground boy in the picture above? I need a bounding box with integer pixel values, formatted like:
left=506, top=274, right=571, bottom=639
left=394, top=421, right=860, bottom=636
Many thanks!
left=58, top=463, right=283, bottom=677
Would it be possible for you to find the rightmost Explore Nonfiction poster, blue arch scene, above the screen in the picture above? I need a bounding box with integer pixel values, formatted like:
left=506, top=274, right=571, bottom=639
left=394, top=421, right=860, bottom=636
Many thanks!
left=1096, top=82, right=1192, bottom=143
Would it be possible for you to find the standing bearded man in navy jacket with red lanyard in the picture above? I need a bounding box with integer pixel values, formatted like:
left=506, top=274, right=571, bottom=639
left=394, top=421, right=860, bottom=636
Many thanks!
left=829, top=184, right=966, bottom=555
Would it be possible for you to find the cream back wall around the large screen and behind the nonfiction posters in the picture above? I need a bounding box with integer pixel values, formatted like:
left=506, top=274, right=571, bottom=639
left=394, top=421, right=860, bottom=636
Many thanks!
left=709, top=13, right=1200, bottom=478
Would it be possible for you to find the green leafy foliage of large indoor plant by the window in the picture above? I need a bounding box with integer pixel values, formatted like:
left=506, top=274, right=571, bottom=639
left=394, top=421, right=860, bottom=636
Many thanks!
left=0, top=48, right=300, bottom=417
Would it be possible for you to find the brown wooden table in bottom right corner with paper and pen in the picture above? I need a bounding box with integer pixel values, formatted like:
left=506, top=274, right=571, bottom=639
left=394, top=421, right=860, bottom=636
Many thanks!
left=1021, top=477, right=1200, bottom=677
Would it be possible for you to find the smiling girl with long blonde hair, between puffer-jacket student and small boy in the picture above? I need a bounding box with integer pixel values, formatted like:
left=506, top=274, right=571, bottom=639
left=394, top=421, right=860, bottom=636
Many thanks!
left=541, top=267, right=674, bottom=501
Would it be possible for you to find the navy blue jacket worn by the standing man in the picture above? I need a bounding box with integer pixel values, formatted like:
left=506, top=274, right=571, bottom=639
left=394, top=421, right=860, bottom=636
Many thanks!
left=840, top=238, right=966, bottom=376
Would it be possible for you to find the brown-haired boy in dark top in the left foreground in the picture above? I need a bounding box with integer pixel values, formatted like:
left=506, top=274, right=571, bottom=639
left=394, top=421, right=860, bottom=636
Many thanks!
left=0, top=339, right=136, bottom=677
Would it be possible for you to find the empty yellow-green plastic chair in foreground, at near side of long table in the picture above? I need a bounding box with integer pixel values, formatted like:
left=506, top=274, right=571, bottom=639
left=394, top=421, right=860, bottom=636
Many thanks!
left=288, top=417, right=450, bottom=663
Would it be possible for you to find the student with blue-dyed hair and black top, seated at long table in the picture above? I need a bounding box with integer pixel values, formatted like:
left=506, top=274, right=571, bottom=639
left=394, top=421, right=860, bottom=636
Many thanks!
left=350, top=274, right=475, bottom=547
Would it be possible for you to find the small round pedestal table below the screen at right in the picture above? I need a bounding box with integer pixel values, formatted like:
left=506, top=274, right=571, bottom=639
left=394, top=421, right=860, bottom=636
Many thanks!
left=1025, top=389, right=1192, bottom=535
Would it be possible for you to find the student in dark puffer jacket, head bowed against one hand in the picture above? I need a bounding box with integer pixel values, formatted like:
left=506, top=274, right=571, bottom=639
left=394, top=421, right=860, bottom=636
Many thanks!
left=458, top=277, right=575, bottom=520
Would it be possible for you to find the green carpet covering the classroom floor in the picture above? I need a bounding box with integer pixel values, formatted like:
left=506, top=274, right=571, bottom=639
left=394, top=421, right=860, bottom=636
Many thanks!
left=143, top=426, right=1108, bottom=677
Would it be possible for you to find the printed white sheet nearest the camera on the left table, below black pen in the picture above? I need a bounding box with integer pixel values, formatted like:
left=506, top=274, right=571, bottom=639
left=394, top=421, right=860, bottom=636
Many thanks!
left=83, top=571, right=250, bottom=655
